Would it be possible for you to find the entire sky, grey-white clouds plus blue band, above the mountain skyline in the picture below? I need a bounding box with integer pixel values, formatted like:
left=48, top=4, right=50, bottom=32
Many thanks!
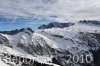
left=0, top=0, right=100, bottom=30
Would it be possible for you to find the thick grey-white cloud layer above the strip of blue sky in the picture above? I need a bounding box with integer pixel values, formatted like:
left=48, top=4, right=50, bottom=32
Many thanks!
left=0, top=0, right=100, bottom=20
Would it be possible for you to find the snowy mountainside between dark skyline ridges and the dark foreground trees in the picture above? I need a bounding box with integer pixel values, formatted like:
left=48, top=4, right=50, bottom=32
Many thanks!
left=0, top=24, right=100, bottom=66
